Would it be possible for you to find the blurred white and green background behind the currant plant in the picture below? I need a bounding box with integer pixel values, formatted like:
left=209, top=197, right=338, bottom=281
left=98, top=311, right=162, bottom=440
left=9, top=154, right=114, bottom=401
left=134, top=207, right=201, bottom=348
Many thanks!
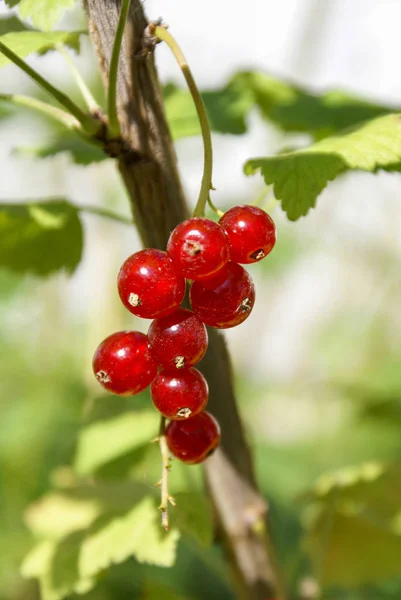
left=0, top=0, right=401, bottom=600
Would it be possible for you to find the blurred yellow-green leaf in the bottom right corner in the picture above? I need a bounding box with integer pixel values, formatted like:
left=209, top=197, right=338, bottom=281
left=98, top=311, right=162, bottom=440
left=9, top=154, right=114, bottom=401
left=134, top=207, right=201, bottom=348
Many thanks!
left=307, top=463, right=401, bottom=586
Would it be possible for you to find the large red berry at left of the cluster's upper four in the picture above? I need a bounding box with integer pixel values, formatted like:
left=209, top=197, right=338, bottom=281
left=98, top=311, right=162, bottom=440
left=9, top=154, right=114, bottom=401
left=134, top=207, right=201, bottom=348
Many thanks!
left=118, top=248, right=185, bottom=319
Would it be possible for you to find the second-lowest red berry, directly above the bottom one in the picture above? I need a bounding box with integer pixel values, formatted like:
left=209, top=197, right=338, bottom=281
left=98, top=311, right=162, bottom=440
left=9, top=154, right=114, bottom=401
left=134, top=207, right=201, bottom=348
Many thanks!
left=150, top=369, right=209, bottom=420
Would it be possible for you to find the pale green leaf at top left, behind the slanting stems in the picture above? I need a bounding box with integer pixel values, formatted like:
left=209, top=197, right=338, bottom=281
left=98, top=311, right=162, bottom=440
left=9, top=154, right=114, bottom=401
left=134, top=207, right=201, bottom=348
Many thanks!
left=0, top=31, right=85, bottom=67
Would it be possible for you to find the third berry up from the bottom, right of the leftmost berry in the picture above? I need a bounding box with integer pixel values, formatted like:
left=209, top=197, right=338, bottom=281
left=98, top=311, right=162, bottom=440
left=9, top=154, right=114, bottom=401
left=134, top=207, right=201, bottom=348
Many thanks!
left=148, top=308, right=208, bottom=369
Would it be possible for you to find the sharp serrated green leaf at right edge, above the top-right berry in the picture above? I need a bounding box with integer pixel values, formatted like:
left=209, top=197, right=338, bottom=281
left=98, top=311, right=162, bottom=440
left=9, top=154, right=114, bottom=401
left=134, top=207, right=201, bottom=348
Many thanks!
left=244, top=114, right=401, bottom=220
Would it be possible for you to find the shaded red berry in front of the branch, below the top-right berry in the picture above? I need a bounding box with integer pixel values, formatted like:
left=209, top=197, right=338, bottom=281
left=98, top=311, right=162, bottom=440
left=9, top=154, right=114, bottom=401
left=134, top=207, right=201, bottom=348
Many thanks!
left=189, top=262, right=255, bottom=329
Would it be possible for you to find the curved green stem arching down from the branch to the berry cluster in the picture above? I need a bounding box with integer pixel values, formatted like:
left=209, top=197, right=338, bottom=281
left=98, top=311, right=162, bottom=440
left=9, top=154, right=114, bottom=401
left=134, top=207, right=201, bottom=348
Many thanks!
left=150, top=26, right=213, bottom=217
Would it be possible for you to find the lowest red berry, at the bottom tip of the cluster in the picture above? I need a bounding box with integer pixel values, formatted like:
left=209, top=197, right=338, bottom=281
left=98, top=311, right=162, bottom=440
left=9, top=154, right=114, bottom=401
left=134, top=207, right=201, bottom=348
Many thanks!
left=166, top=411, right=221, bottom=465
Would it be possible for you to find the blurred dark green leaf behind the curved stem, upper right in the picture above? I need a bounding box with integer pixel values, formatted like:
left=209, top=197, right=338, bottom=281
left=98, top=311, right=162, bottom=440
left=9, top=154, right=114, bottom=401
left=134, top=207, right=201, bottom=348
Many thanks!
left=164, top=71, right=394, bottom=139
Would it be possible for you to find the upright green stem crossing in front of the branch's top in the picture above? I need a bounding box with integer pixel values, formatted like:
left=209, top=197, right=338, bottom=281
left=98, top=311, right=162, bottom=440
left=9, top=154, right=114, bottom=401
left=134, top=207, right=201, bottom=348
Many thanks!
left=107, top=0, right=131, bottom=138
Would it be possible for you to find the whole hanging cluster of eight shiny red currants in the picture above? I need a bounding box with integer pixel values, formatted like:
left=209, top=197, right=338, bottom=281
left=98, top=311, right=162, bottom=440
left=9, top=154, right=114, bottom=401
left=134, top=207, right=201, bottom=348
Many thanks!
left=93, top=206, right=276, bottom=464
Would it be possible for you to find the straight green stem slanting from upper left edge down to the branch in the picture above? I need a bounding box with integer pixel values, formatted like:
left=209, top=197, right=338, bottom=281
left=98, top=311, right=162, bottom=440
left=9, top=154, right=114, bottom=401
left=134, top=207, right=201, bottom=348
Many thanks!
left=0, top=42, right=100, bottom=135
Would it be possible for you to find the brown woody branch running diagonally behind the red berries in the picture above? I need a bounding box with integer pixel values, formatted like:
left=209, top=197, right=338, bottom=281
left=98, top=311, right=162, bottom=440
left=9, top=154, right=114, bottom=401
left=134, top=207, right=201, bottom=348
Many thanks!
left=85, top=0, right=277, bottom=600
